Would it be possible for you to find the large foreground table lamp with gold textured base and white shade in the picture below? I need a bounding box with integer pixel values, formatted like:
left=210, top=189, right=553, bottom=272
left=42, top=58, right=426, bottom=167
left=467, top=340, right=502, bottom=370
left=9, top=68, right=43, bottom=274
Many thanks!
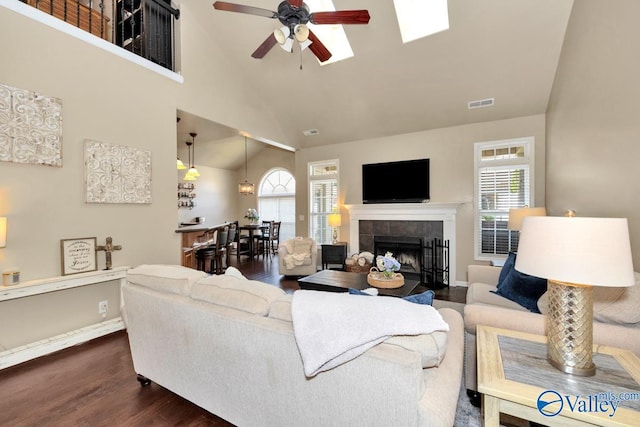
left=515, top=216, right=635, bottom=376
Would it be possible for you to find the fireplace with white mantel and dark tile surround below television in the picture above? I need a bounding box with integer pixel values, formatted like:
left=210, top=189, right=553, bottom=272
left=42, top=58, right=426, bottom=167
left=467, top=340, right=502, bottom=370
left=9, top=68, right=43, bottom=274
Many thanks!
left=345, top=203, right=462, bottom=286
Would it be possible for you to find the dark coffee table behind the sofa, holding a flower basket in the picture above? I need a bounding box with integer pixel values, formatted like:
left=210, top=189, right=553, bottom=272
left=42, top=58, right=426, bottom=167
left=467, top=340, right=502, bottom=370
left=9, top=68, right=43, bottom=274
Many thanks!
left=298, top=270, right=420, bottom=297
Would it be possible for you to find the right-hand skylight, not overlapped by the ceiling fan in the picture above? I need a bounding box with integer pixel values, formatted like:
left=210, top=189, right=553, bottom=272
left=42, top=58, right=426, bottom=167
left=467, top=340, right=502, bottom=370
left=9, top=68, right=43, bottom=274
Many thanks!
left=393, top=0, right=449, bottom=43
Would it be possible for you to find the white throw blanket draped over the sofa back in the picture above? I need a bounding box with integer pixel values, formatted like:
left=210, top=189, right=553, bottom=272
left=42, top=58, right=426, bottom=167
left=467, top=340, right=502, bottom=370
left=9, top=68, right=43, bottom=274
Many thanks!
left=291, top=290, right=449, bottom=377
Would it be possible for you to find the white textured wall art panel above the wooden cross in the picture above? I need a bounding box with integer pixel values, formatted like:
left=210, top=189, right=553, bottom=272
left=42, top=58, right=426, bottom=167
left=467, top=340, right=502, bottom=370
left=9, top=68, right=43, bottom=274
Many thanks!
left=84, top=140, right=151, bottom=203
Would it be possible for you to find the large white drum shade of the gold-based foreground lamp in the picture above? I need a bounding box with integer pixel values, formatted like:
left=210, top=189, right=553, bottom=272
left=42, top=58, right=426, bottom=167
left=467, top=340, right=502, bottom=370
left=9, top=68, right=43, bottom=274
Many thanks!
left=515, top=216, right=635, bottom=287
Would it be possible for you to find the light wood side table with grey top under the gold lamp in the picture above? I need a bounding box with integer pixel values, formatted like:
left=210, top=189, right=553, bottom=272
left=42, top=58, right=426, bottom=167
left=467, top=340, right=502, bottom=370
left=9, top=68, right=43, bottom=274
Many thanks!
left=476, top=325, right=640, bottom=427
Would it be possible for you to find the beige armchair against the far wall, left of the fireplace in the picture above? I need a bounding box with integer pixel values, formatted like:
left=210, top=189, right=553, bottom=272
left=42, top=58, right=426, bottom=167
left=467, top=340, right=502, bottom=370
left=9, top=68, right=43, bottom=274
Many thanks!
left=278, top=237, right=318, bottom=276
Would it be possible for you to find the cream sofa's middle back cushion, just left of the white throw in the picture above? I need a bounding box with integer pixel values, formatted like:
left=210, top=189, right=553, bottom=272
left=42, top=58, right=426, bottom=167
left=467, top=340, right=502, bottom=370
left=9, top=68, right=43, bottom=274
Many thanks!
left=191, top=275, right=285, bottom=316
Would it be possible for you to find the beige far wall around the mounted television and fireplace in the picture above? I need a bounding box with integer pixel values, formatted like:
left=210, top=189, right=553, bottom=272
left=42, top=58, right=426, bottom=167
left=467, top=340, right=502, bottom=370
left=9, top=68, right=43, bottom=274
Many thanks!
left=296, top=115, right=545, bottom=281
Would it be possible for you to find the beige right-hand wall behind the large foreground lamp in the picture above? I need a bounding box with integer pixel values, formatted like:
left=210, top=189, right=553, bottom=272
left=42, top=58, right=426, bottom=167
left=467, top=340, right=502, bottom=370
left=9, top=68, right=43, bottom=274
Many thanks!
left=547, top=0, right=640, bottom=271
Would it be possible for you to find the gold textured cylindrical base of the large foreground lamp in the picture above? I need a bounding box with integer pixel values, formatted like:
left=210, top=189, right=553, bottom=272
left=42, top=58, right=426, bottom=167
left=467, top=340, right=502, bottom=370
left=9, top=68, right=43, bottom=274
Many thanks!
left=547, top=280, right=596, bottom=377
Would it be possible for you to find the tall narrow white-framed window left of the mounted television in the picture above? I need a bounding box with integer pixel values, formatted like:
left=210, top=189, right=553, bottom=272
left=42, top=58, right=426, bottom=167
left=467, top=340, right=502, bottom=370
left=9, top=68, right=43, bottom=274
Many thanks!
left=309, top=160, right=338, bottom=244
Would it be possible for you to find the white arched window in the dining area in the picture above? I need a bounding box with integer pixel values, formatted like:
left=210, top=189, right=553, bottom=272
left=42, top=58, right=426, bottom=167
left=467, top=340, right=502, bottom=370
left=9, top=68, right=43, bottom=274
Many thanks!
left=258, top=168, right=296, bottom=242
